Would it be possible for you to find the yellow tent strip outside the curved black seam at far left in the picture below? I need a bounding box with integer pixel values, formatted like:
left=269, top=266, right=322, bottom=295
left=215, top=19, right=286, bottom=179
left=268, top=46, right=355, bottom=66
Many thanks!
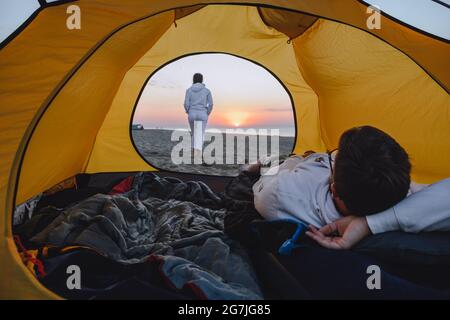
left=0, top=0, right=173, bottom=298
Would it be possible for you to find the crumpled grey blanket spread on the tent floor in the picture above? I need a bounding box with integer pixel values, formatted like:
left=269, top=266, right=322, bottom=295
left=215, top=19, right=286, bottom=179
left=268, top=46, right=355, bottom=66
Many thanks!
left=31, top=173, right=262, bottom=299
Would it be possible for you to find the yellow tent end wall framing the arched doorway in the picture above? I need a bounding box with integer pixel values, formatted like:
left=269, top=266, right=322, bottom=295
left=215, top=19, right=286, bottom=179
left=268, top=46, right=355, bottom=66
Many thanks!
left=86, top=6, right=325, bottom=173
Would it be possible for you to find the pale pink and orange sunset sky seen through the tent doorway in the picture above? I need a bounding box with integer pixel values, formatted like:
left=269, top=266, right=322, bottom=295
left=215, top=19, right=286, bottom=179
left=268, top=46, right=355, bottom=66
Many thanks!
left=133, top=54, right=295, bottom=136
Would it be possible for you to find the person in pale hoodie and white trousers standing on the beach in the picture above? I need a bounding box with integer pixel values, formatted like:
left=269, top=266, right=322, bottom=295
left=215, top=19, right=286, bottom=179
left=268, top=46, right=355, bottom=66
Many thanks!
left=184, top=73, right=213, bottom=162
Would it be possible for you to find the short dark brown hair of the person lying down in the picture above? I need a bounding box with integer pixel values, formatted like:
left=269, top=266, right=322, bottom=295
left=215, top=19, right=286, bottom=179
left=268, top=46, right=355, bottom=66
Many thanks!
left=333, top=126, right=411, bottom=216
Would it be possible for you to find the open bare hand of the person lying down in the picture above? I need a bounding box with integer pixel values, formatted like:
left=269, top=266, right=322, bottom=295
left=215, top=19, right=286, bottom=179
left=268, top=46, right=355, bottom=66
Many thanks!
left=306, top=216, right=371, bottom=250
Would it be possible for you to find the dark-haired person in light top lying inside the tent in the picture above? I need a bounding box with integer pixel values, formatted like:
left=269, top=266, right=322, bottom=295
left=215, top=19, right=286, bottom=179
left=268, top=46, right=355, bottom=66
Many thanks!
left=244, top=126, right=450, bottom=249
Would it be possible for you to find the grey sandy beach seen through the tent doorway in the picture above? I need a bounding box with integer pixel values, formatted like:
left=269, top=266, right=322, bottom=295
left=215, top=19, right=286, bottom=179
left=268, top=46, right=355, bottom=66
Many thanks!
left=132, top=129, right=294, bottom=176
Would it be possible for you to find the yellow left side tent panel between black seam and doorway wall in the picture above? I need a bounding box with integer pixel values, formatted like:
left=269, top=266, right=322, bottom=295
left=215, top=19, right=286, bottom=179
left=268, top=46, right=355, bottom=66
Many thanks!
left=17, top=11, right=174, bottom=208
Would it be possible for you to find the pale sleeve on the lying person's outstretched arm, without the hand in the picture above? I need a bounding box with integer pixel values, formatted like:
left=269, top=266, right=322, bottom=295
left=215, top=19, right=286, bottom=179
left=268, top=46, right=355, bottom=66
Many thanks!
left=366, top=178, right=450, bottom=234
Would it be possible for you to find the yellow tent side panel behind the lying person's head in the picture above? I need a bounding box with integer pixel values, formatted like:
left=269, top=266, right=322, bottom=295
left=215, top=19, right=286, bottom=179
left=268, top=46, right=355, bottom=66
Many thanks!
left=293, top=19, right=450, bottom=183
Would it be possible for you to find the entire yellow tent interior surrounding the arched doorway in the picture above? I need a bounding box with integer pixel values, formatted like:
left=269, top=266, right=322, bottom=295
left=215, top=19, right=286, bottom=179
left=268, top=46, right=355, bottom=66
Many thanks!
left=0, top=0, right=450, bottom=298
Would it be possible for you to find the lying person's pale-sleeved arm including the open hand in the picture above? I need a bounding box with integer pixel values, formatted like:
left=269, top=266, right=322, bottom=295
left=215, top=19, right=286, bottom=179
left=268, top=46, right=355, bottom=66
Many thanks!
left=307, top=178, right=450, bottom=249
